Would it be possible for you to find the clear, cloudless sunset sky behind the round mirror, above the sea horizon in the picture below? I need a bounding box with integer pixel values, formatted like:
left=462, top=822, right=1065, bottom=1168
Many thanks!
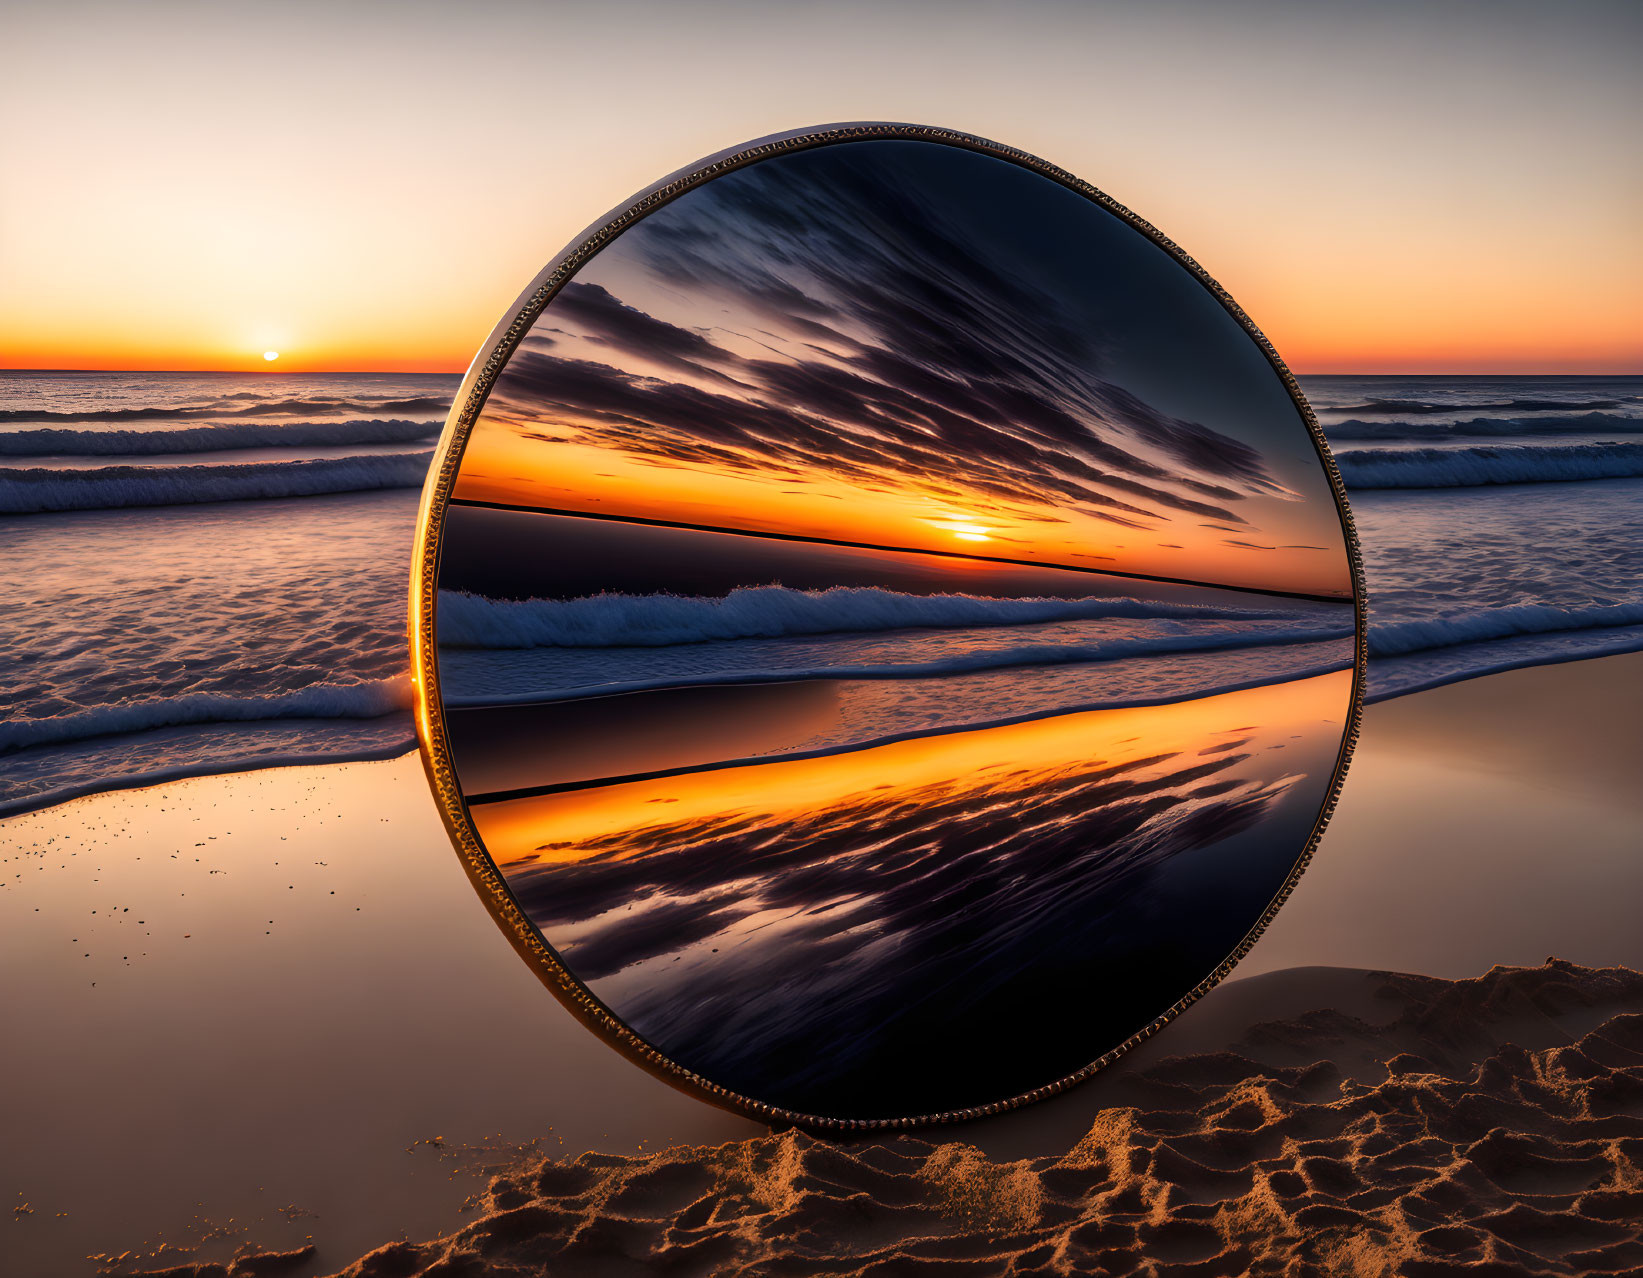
left=0, top=2, right=1643, bottom=373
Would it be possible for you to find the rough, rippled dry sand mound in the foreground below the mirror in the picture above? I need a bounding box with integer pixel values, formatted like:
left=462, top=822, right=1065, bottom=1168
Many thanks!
left=141, top=961, right=1643, bottom=1278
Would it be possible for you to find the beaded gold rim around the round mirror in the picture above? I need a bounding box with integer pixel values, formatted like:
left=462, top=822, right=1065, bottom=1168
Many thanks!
left=409, top=123, right=1367, bottom=1132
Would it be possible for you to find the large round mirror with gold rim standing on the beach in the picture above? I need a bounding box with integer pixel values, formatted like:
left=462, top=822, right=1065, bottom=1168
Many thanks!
left=412, top=125, right=1362, bottom=1129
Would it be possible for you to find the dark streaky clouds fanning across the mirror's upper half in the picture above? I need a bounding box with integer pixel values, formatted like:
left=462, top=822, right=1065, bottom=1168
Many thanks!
left=493, top=146, right=1294, bottom=529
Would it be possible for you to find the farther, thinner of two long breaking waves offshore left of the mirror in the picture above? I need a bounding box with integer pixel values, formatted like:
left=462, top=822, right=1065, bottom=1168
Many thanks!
left=0, top=417, right=442, bottom=457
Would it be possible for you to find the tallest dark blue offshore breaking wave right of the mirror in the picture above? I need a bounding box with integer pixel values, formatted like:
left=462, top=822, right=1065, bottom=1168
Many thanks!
left=1336, top=444, right=1643, bottom=490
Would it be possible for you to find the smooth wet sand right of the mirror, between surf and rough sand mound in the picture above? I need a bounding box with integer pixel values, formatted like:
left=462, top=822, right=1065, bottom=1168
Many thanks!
left=1237, top=652, right=1643, bottom=977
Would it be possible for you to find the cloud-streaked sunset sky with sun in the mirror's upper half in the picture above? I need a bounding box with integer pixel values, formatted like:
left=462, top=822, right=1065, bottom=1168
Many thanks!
left=453, top=141, right=1351, bottom=595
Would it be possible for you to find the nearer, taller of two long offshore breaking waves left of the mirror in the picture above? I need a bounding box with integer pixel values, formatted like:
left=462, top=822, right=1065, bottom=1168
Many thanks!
left=0, top=452, right=434, bottom=514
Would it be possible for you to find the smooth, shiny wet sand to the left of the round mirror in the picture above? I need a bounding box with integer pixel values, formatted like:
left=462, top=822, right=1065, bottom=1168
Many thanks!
left=0, top=756, right=756, bottom=1278
